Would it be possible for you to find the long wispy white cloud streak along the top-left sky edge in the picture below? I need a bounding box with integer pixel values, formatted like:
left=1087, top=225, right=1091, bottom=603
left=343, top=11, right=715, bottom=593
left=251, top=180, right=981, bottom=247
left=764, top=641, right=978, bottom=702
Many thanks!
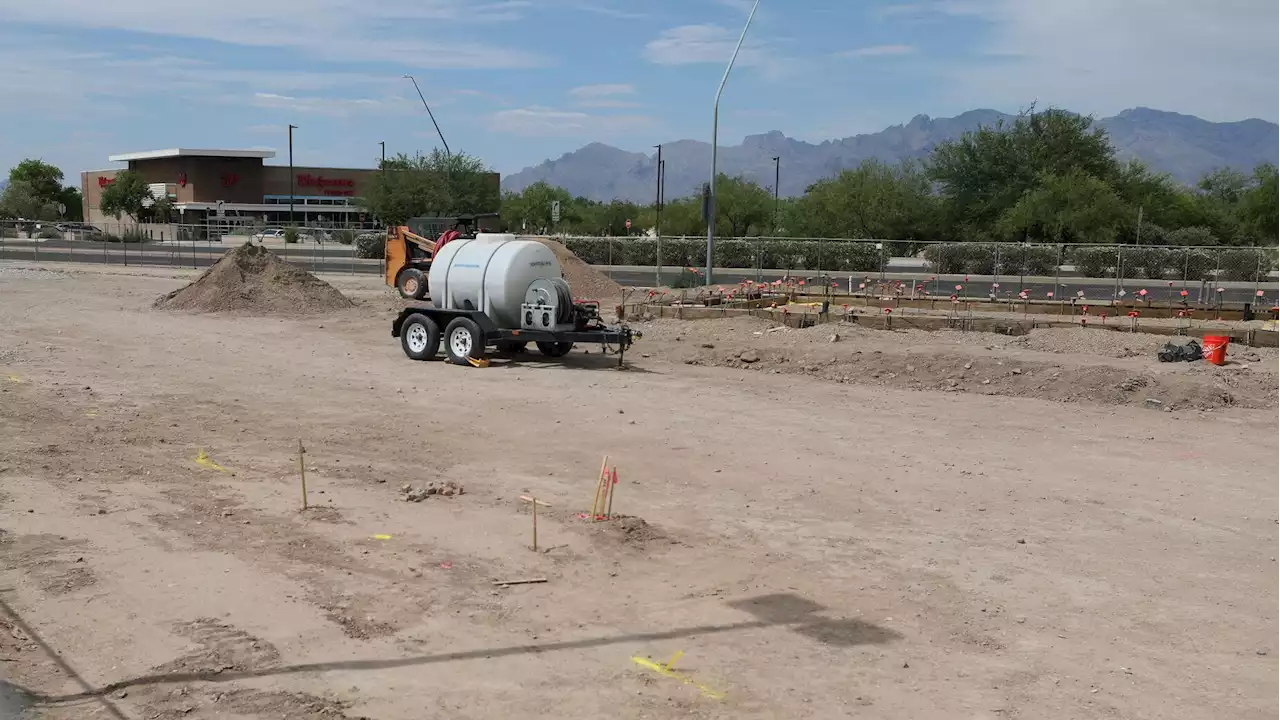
left=0, top=0, right=547, bottom=69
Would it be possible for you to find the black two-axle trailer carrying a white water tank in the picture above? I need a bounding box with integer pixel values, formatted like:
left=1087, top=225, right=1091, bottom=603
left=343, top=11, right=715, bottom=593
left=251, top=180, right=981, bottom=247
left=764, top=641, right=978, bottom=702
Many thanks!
left=392, top=233, right=640, bottom=365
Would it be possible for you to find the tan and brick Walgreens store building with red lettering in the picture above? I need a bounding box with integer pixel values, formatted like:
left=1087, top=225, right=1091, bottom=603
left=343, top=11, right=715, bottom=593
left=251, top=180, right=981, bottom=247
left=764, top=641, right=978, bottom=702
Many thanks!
left=81, top=147, right=378, bottom=225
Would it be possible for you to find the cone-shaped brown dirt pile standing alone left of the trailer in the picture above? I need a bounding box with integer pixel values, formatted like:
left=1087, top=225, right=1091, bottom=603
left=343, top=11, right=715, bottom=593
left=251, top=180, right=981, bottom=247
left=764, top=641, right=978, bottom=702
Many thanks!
left=155, top=243, right=352, bottom=315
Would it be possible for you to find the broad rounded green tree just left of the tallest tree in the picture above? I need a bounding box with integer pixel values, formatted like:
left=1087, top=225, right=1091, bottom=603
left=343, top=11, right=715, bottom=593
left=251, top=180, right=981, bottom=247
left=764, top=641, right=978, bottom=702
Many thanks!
left=787, top=160, right=937, bottom=240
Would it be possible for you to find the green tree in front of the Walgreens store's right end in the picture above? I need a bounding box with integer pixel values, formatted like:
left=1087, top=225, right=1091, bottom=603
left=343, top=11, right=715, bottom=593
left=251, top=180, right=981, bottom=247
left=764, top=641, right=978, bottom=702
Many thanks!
left=360, top=150, right=499, bottom=225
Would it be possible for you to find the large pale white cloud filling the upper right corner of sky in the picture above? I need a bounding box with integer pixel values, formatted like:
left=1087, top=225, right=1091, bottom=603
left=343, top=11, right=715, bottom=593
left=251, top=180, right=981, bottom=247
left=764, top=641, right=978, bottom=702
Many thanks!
left=931, top=0, right=1280, bottom=120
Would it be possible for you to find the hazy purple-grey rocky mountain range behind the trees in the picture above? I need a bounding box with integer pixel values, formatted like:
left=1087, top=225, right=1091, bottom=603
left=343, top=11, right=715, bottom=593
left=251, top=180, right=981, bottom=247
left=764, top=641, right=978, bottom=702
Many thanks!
left=502, top=108, right=1280, bottom=204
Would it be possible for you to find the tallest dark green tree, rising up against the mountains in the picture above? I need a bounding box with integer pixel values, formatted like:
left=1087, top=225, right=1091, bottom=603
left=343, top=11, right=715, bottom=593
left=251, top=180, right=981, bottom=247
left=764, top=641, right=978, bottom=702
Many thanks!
left=928, top=109, right=1120, bottom=232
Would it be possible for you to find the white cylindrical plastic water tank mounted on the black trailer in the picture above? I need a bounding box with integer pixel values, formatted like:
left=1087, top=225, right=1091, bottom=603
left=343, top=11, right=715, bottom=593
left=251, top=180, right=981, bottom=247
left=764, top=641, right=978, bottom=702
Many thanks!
left=428, top=233, right=561, bottom=329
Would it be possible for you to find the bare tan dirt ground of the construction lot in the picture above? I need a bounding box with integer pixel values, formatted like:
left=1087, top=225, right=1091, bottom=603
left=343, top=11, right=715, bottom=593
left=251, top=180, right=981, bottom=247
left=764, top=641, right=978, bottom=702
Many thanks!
left=0, top=260, right=1280, bottom=720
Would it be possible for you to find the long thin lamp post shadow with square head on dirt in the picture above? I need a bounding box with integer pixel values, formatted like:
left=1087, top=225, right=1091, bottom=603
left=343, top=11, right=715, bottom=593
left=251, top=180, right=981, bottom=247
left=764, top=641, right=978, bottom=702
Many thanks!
left=20, top=593, right=901, bottom=705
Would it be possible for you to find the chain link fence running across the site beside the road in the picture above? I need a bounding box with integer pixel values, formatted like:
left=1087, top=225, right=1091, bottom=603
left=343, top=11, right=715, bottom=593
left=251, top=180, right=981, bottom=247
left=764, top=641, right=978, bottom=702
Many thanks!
left=0, top=220, right=1280, bottom=306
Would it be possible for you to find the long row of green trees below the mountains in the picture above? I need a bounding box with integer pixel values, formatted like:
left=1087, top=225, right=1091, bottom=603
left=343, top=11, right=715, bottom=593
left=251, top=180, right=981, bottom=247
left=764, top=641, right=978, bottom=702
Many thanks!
left=502, top=109, right=1280, bottom=246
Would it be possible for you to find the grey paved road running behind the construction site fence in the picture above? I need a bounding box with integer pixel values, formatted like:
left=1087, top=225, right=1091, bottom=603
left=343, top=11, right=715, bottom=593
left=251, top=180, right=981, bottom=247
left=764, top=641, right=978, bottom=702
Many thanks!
left=0, top=240, right=1280, bottom=306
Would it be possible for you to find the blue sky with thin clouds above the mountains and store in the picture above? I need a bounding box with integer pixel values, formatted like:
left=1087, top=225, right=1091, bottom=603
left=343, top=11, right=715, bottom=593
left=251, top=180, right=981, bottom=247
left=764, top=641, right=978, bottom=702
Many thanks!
left=0, top=0, right=1280, bottom=178
